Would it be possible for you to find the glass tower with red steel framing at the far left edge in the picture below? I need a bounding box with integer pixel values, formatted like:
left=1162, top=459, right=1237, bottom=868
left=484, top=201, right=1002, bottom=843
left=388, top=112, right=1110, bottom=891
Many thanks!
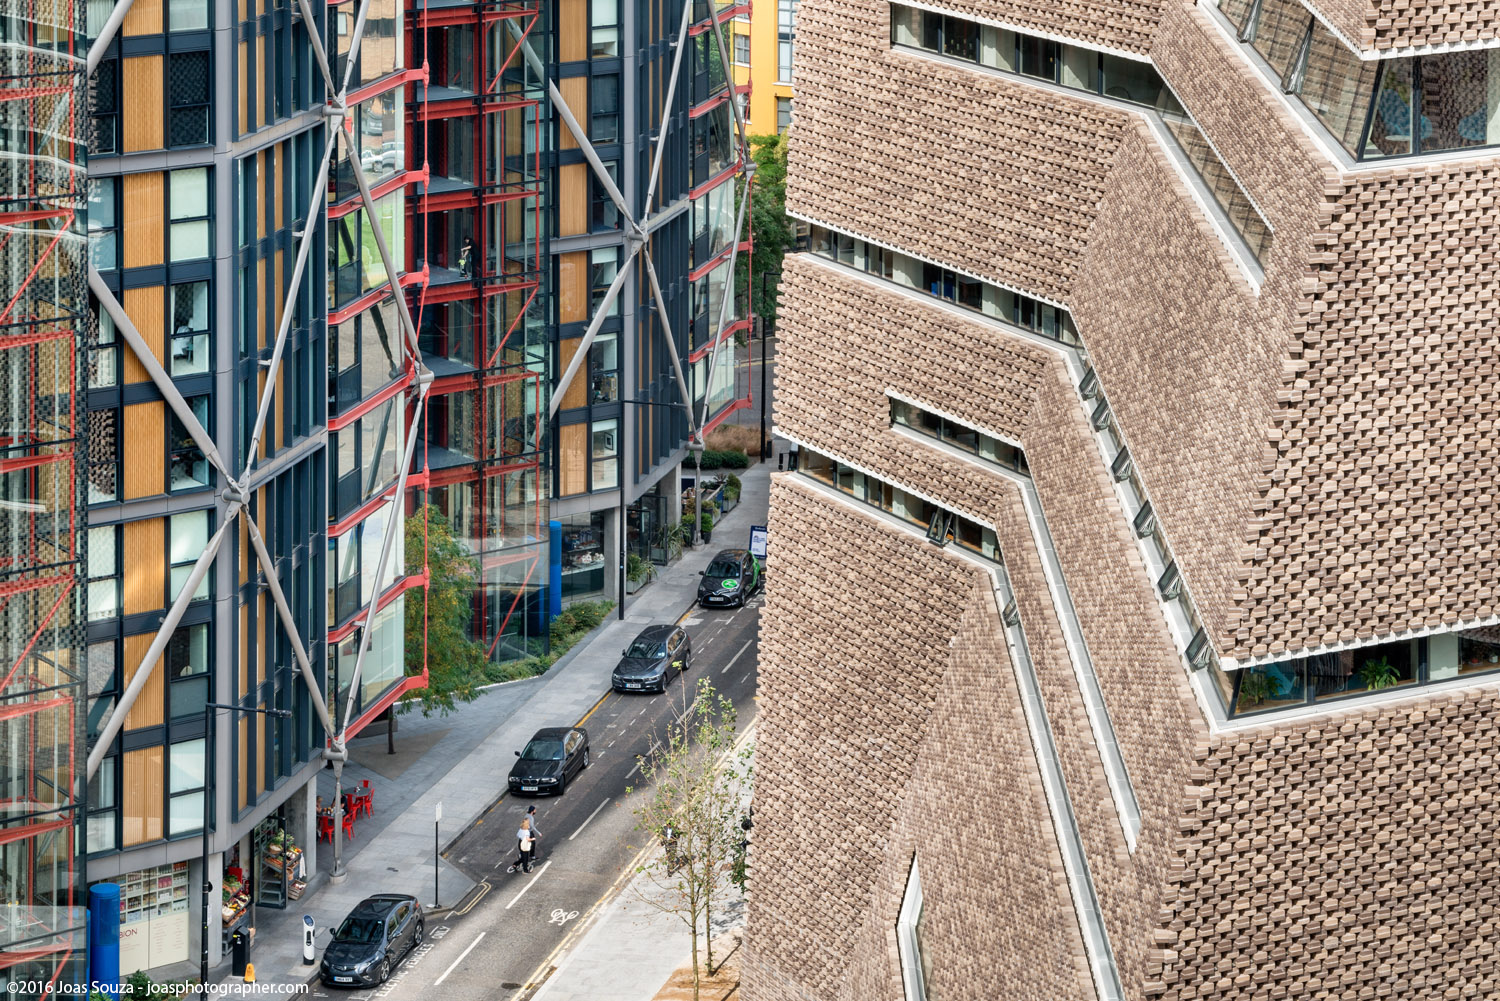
left=0, top=0, right=87, bottom=995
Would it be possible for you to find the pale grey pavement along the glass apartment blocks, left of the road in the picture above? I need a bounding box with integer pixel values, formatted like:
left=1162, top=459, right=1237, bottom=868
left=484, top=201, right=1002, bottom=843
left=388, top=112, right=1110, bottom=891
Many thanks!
left=218, top=462, right=774, bottom=998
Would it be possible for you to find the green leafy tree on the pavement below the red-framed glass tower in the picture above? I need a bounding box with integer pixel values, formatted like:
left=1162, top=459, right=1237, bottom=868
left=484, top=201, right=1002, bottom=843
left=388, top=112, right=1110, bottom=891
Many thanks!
left=407, top=504, right=486, bottom=716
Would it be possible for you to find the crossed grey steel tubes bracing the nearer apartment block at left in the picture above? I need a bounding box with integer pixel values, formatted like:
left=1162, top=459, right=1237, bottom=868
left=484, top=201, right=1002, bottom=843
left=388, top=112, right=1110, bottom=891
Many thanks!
left=89, top=0, right=432, bottom=876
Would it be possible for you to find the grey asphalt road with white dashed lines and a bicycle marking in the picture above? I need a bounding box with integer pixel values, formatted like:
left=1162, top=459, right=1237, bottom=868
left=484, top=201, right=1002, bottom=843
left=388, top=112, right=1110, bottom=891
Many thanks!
left=309, top=593, right=764, bottom=1001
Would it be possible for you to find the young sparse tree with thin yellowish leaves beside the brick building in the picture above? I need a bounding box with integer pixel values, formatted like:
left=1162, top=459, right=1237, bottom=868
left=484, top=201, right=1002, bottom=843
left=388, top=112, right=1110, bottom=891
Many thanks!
left=630, top=678, right=750, bottom=1001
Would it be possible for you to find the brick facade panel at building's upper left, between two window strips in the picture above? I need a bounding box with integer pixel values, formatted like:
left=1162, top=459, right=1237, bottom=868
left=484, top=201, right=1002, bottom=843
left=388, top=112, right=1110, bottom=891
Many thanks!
left=788, top=0, right=1127, bottom=300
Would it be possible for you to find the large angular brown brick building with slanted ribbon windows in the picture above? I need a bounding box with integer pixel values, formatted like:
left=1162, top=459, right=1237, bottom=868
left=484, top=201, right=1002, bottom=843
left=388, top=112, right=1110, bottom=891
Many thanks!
left=744, top=0, right=1500, bottom=1001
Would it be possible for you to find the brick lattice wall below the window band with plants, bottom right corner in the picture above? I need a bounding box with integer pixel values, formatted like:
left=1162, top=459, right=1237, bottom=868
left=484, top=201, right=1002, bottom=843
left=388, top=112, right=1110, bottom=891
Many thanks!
left=1160, top=687, right=1500, bottom=1001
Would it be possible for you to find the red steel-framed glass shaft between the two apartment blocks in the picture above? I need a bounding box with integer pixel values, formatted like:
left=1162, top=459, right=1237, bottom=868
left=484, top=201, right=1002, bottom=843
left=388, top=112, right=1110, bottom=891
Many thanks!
left=407, top=0, right=548, bottom=660
